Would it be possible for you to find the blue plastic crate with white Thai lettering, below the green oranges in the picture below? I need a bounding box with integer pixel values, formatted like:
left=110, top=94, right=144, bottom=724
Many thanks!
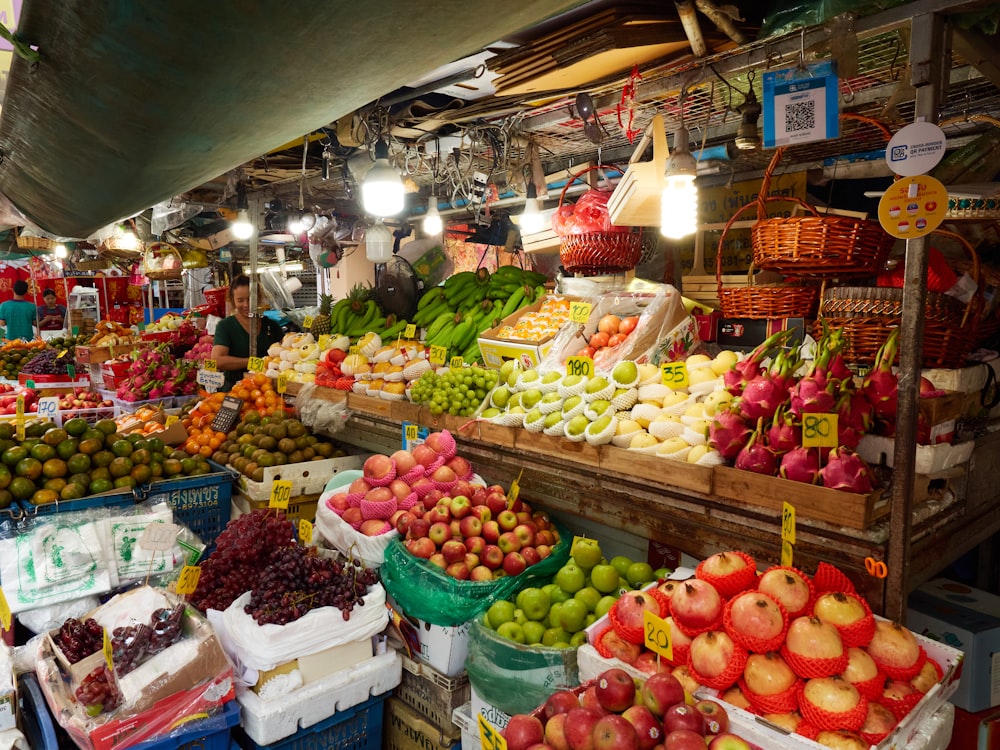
left=142, top=464, right=236, bottom=545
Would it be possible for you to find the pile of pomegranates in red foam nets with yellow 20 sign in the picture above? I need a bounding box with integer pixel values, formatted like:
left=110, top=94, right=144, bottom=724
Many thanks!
left=594, top=552, right=943, bottom=748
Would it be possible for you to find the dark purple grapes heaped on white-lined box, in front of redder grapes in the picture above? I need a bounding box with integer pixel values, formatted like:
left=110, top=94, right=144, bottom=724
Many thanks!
left=244, top=546, right=378, bottom=625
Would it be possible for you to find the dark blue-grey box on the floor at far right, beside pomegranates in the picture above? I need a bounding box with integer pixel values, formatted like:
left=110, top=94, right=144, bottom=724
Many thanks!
left=906, top=578, right=1000, bottom=712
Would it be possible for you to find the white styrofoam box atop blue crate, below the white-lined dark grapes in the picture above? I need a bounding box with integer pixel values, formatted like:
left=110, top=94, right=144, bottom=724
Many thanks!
left=236, top=650, right=403, bottom=745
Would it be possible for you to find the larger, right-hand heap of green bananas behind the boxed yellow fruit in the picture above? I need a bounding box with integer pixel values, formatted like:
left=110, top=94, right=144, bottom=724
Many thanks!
left=412, top=266, right=545, bottom=362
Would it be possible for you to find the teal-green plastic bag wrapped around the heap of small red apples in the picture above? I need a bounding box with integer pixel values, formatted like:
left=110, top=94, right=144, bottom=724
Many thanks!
left=379, top=522, right=573, bottom=627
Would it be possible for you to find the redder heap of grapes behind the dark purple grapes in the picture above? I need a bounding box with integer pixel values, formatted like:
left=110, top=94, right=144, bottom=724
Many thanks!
left=191, top=509, right=296, bottom=612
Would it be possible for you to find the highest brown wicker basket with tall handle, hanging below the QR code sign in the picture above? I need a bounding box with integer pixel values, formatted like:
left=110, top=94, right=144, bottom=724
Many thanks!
left=750, top=115, right=895, bottom=277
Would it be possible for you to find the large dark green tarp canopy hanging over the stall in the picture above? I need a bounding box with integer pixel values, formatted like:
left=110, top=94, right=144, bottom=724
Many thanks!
left=0, top=0, right=580, bottom=238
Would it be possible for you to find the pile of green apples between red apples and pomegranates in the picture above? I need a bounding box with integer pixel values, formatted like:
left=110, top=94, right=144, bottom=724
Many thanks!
left=482, top=537, right=666, bottom=648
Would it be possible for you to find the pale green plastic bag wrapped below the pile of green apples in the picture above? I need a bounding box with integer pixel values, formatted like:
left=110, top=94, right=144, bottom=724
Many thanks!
left=465, top=622, right=580, bottom=714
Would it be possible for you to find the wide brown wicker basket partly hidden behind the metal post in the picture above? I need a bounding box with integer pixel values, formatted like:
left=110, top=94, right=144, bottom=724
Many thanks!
left=813, top=230, right=983, bottom=368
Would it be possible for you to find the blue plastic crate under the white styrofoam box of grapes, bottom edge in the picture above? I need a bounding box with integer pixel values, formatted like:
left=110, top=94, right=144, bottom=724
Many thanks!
left=233, top=691, right=392, bottom=750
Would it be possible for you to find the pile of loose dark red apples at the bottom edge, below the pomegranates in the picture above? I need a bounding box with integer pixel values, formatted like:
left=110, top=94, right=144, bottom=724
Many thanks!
left=503, top=669, right=757, bottom=750
